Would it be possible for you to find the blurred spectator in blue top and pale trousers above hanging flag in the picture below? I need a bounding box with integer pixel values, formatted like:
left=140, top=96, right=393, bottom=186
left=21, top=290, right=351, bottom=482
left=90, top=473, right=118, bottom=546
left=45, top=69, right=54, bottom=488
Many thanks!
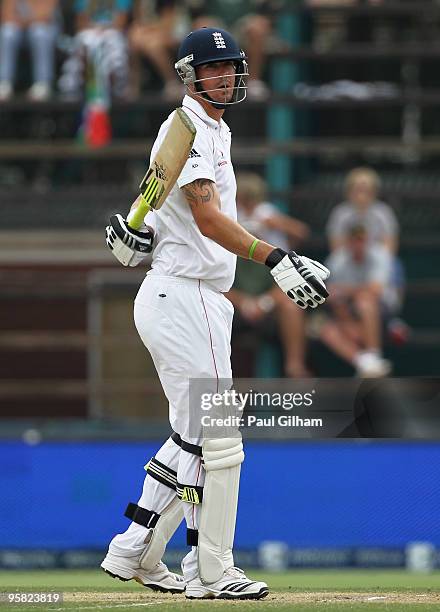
left=59, top=0, right=132, bottom=99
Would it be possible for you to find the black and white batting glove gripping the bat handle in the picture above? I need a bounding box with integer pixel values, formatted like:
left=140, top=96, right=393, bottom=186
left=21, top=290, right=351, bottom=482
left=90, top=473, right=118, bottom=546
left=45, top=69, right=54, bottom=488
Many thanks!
left=105, top=214, right=154, bottom=267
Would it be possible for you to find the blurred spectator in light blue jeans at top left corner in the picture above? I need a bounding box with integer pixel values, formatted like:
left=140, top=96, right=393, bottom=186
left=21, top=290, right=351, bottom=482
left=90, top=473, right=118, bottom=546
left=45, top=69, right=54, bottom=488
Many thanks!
left=0, top=0, right=58, bottom=101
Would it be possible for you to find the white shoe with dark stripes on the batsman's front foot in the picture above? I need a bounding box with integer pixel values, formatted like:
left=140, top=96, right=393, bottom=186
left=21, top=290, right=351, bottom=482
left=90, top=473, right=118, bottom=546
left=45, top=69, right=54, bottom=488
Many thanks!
left=185, top=567, right=269, bottom=599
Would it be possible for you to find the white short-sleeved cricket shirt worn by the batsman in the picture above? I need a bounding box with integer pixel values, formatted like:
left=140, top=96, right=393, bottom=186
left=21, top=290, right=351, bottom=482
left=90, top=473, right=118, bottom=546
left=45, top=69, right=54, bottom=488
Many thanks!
left=145, top=96, right=237, bottom=292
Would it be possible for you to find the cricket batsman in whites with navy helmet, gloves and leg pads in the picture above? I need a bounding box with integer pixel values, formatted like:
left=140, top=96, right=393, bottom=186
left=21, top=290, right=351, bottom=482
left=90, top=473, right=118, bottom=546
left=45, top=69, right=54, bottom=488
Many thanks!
left=102, top=28, right=329, bottom=599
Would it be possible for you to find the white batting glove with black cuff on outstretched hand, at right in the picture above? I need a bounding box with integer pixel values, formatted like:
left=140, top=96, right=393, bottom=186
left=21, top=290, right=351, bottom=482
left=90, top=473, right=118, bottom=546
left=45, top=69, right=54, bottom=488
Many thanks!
left=266, top=249, right=330, bottom=310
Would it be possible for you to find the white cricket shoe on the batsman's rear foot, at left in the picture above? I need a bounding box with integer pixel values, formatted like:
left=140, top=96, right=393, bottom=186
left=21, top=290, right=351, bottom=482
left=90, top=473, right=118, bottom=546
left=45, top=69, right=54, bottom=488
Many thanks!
left=101, top=553, right=186, bottom=593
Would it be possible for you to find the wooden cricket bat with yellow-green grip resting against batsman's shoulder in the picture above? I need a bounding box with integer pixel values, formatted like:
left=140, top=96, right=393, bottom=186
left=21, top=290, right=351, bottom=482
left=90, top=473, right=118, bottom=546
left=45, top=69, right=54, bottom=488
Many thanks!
left=128, top=108, right=196, bottom=229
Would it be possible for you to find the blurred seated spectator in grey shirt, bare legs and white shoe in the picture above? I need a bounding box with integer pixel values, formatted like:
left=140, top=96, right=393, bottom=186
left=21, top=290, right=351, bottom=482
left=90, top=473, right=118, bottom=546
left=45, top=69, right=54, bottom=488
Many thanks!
left=320, top=225, right=395, bottom=378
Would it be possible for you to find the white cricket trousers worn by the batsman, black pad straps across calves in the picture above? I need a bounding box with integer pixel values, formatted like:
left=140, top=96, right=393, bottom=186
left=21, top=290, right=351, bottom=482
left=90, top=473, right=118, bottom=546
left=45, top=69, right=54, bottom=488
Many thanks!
left=110, top=273, right=234, bottom=580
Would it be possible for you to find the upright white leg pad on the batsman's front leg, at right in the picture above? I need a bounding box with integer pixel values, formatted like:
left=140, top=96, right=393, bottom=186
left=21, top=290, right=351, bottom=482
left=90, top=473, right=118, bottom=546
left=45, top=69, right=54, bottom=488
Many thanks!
left=198, top=436, right=244, bottom=584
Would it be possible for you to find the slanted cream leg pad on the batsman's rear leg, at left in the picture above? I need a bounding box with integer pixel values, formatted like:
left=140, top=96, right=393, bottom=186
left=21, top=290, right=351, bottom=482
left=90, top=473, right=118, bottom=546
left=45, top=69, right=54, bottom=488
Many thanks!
left=140, top=497, right=183, bottom=571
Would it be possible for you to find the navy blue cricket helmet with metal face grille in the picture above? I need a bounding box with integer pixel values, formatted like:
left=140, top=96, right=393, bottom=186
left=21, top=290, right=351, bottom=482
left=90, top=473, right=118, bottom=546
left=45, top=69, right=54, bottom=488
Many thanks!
left=175, top=28, right=249, bottom=108
